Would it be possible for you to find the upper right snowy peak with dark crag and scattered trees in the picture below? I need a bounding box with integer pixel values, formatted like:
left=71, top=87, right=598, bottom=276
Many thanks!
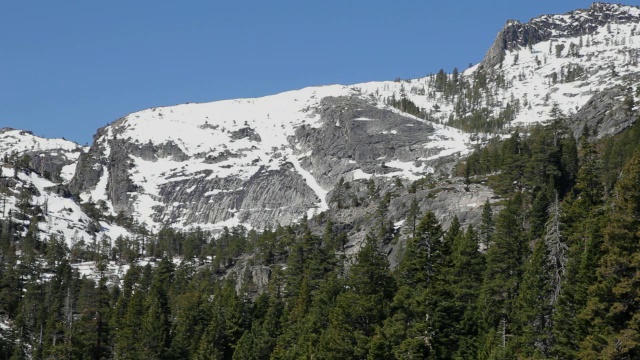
left=356, top=3, right=640, bottom=131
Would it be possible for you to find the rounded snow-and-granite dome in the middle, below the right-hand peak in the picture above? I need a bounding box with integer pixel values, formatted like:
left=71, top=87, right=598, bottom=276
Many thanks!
left=70, top=86, right=468, bottom=229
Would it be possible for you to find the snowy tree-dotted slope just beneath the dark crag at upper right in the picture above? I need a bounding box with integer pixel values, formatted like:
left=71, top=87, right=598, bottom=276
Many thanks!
left=501, top=23, right=640, bottom=124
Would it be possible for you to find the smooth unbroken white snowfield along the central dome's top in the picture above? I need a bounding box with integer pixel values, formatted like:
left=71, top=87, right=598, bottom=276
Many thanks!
left=115, top=85, right=351, bottom=156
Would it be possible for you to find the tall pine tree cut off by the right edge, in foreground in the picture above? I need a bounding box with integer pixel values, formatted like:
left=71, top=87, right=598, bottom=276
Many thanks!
left=580, top=150, right=640, bottom=359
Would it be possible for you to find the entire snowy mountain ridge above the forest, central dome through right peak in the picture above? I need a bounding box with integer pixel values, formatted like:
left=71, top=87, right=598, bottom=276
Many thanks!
left=0, top=3, right=640, bottom=239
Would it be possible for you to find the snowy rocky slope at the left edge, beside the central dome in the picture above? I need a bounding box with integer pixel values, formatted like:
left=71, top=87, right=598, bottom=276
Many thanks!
left=0, top=128, right=129, bottom=246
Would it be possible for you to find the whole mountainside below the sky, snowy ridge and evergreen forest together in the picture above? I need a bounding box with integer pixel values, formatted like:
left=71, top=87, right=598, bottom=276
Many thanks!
left=0, top=3, right=640, bottom=359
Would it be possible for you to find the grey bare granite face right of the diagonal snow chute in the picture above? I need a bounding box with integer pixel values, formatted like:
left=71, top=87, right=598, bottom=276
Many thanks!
left=291, top=97, right=456, bottom=189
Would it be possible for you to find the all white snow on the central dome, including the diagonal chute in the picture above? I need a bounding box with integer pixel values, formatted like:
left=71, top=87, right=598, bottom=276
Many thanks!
left=92, top=79, right=476, bottom=229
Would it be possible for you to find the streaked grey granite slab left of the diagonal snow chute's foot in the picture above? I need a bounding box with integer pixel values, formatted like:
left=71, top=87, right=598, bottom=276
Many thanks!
left=155, top=167, right=319, bottom=229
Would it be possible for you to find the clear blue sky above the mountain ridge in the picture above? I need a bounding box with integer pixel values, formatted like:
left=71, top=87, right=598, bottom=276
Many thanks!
left=0, top=0, right=604, bottom=144
